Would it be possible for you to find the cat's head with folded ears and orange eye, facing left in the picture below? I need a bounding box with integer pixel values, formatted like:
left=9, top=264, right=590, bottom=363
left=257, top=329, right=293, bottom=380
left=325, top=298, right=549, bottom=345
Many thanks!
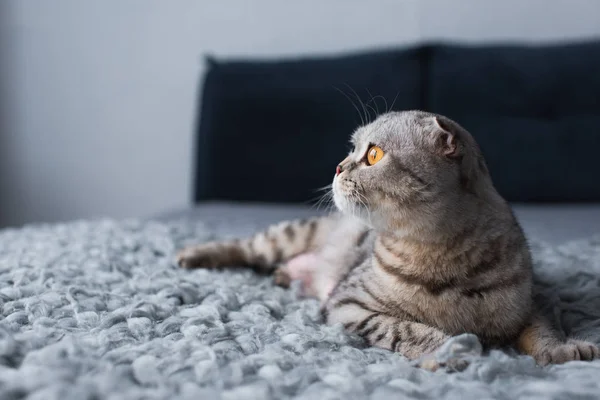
left=333, top=111, right=494, bottom=233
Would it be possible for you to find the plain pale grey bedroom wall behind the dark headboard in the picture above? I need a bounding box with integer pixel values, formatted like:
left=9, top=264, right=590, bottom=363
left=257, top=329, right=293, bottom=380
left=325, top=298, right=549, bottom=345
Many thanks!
left=0, top=0, right=600, bottom=225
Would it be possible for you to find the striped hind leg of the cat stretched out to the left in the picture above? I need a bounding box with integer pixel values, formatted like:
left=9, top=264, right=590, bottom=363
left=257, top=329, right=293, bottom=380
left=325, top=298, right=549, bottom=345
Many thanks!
left=177, top=216, right=336, bottom=272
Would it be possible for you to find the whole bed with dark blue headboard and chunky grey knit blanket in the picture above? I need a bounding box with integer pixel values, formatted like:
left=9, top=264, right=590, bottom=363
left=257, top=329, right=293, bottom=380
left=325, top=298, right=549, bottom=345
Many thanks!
left=0, top=42, right=600, bottom=400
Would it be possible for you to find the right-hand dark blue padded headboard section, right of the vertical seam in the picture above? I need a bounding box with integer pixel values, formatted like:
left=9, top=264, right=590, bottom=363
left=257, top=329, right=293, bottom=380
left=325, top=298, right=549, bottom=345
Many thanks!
left=425, top=42, right=600, bottom=201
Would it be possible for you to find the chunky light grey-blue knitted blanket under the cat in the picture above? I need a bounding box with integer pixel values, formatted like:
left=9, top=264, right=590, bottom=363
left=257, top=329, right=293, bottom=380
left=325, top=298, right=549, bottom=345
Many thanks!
left=0, top=221, right=600, bottom=400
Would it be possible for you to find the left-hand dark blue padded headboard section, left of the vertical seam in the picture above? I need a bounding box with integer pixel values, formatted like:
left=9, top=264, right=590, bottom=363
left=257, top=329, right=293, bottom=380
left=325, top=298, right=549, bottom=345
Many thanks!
left=195, top=49, right=422, bottom=202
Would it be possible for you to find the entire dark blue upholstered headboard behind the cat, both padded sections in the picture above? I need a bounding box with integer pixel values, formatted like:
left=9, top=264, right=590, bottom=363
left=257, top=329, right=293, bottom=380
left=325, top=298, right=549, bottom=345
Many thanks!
left=194, top=41, right=600, bottom=202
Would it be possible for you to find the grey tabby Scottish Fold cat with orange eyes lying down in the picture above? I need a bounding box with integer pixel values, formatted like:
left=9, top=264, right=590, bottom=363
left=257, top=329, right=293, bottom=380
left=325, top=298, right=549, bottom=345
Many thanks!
left=178, top=111, right=598, bottom=365
